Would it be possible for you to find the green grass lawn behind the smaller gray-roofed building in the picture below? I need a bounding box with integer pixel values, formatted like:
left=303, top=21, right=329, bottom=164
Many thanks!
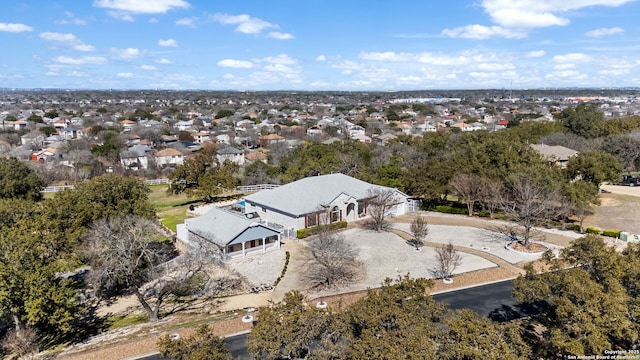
left=149, top=185, right=200, bottom=232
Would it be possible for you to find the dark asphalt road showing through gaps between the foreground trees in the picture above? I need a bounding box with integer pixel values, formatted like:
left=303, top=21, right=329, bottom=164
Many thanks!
left=140, top=280, right=540, bottom=360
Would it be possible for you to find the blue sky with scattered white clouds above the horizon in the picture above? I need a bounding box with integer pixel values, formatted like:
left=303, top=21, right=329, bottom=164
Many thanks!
left=0, top=0, right=640, bottom=91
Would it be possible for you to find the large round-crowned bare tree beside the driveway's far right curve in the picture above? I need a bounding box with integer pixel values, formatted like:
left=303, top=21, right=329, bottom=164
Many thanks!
left=500, top=174, right=559, bottom=247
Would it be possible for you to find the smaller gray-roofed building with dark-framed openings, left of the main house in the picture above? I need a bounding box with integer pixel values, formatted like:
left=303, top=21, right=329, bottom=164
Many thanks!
left=177, top=207, right=280, bottom=260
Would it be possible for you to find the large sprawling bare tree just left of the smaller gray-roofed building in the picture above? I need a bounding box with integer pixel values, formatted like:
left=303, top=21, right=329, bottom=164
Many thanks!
left=84, top=215, right=200, bottom=321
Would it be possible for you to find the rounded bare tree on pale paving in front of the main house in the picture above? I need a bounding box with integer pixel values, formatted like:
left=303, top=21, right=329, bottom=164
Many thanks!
left=302, top=232, right=360, bottom=287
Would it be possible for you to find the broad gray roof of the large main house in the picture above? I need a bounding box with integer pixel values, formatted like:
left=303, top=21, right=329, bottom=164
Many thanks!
left=245, top=174, right=404, bottom=216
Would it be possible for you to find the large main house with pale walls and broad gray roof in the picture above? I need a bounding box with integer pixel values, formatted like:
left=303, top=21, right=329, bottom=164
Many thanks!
left=244, top=174, right=408, bottom=230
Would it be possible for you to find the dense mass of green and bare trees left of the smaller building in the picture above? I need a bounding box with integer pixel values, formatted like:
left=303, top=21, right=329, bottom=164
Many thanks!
left=0, top=158, right=206, bottom=355
